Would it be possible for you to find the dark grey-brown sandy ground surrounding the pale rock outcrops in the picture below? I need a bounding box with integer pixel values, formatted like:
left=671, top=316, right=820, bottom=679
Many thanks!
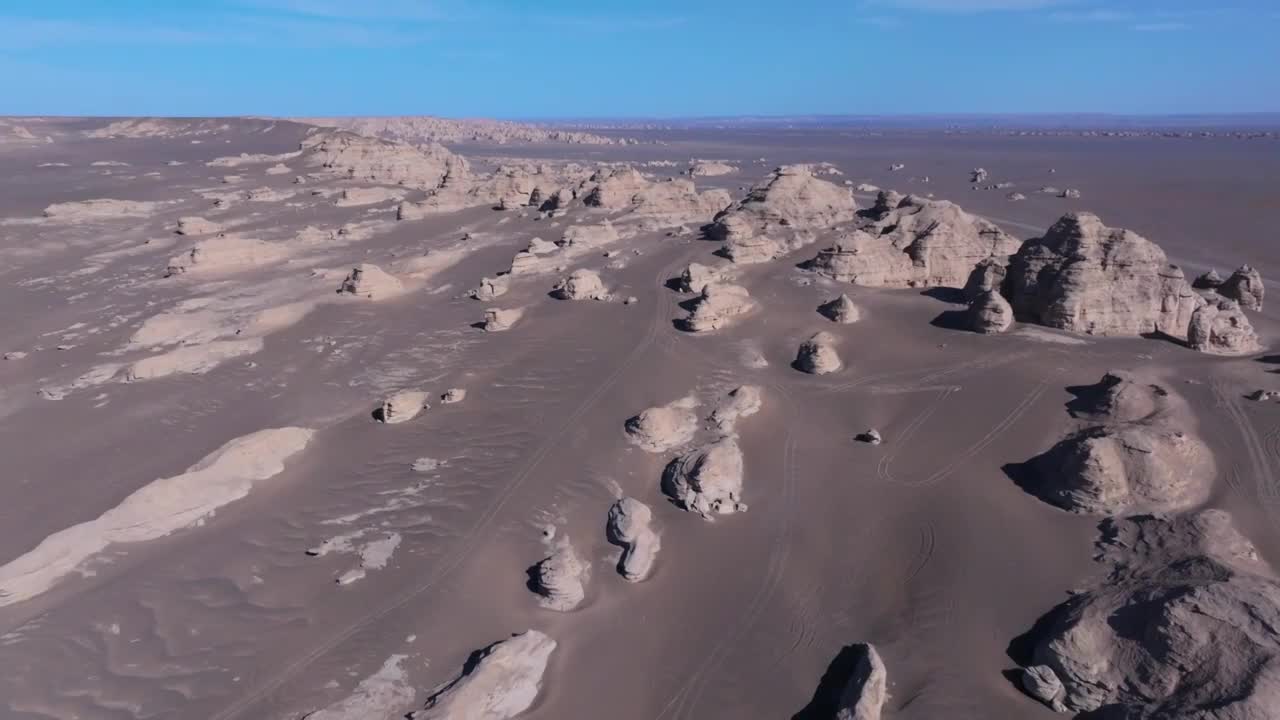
left=0, top=117, right=1280, bottom=720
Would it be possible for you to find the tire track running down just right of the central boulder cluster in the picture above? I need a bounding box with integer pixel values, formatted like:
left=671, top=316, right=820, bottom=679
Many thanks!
left=654, top=384, right=797, bottom=720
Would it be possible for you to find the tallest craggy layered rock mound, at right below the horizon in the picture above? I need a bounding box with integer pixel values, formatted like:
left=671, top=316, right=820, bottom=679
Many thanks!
left=1005, top=213, right=1204, bottom=338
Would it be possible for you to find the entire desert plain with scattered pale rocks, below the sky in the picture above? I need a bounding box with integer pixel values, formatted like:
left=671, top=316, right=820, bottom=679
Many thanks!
left=0, top=118, right=1280, bottom=720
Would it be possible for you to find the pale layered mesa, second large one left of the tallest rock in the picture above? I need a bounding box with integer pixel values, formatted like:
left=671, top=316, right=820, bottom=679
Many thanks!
left=708, top=165, right=858, bottom=258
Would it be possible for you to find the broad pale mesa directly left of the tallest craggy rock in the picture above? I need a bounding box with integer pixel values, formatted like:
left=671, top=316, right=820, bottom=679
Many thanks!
left=808, top=193, right=1019, bottom=288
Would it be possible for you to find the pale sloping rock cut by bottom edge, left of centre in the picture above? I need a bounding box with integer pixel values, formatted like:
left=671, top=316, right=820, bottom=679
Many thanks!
left=411, top=630, right=556, bottom=720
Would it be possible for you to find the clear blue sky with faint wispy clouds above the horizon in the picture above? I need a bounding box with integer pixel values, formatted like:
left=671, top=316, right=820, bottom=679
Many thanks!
left=0, top=0, right=1280, bottom=118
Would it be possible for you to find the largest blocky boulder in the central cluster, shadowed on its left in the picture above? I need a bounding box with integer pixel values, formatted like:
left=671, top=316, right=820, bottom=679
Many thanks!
left=662, top=436, right=746, bottom=519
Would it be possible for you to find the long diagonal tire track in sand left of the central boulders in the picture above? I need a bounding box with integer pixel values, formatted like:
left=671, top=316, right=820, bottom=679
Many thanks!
left=209, top=251, right=684, bottom=720
